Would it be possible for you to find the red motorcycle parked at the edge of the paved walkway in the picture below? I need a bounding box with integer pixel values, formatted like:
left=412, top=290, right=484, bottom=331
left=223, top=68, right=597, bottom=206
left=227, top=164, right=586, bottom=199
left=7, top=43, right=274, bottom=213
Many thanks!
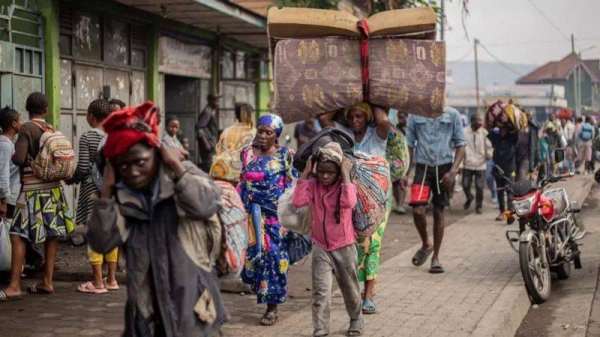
left=493, top=150, right=585, bottom=304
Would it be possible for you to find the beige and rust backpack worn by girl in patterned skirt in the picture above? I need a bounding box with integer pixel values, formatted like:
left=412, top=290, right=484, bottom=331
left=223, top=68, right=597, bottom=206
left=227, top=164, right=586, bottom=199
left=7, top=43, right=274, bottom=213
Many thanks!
left=31, top=122, right=77, bottom=181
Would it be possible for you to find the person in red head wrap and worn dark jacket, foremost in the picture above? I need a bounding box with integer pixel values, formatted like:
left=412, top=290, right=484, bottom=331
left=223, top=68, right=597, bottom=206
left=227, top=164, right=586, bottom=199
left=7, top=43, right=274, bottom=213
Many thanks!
left=87, top=102, right=228, bottom=337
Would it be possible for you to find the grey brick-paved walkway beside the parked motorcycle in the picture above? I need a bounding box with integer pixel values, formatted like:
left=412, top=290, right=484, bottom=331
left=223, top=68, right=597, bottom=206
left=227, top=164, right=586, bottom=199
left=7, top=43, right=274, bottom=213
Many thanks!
left=248, top=176, right=593, bottom=337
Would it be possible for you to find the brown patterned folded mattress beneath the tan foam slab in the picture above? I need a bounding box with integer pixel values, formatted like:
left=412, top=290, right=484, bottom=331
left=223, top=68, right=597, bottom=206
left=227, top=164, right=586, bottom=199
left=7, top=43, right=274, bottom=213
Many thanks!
left=273, top=38, right=446, bottom=123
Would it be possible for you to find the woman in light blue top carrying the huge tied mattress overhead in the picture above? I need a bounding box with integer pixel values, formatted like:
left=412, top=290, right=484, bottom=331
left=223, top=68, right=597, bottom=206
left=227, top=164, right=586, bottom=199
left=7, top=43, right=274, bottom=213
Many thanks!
left=319, top=103, right=392, bottom=314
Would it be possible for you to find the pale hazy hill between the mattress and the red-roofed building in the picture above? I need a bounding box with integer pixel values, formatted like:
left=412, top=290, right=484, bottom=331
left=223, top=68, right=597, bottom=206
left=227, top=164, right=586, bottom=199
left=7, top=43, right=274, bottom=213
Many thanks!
left=447, top=61, right=538, bottom=87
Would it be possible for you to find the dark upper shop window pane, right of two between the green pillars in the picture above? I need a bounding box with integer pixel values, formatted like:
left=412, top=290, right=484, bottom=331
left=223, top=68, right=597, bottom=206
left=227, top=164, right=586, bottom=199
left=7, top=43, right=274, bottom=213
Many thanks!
left=104, top=19, right=130, bottom=66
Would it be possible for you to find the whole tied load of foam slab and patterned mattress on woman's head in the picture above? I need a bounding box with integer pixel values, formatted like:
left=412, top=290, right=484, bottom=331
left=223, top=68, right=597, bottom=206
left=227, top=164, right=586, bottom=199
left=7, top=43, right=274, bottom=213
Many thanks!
left=267, top=7, right=446, bottom=123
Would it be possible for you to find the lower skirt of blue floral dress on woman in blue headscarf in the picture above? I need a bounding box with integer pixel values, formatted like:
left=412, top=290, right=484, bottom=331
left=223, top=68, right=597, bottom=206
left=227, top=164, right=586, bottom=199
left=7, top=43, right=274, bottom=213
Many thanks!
left=241, top=205, right=289, bottom=304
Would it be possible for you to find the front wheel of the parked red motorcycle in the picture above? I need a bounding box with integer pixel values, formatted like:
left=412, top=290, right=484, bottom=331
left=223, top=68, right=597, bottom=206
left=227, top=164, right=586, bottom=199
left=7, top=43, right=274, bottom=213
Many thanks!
left=519, top=236, right=551, bottom=304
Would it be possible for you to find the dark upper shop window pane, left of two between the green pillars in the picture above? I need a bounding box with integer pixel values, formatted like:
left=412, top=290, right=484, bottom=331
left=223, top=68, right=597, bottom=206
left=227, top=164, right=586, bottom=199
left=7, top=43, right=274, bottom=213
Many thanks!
left=73, top=12, right=102, bottom=60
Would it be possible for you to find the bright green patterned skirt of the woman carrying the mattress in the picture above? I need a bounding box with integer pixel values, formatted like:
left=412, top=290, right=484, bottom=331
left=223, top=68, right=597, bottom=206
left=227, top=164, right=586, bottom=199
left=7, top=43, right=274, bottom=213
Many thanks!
left=356, top=195, right=392, bottom=282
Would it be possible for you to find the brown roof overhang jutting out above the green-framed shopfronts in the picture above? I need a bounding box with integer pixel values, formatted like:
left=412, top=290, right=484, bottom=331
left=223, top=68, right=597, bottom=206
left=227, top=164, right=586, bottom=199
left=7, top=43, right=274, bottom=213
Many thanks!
left=117, top=0, right=268, bottom=49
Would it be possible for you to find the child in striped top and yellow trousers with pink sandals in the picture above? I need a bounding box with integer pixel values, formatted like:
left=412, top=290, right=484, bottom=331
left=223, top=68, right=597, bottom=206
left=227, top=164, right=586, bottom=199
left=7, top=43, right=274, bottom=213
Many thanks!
left=68, top=99, right=119, bottom=294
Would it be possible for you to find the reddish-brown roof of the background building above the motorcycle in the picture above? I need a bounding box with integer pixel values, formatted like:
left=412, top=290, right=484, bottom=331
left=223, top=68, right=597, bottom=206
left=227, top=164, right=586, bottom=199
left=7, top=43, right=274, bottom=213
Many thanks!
left=517, top=53, right=600, bottom=84
